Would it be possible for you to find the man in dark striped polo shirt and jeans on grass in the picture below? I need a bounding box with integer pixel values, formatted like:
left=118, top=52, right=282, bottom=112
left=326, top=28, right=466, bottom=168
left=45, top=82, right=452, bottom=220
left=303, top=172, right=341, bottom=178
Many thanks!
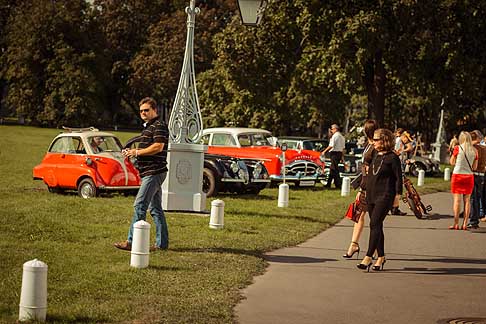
left=115, top=97, right=169, bottom=251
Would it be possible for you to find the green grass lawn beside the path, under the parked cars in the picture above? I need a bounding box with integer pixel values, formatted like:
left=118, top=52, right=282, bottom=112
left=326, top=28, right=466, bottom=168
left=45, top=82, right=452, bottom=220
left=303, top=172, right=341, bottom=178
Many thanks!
left=0, top=126, right=449, bottom=323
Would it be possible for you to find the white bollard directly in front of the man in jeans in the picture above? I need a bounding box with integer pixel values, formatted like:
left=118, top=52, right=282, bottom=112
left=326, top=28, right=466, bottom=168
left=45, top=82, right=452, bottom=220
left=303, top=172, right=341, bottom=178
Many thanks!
left=130, top=220, right=150, bottom=268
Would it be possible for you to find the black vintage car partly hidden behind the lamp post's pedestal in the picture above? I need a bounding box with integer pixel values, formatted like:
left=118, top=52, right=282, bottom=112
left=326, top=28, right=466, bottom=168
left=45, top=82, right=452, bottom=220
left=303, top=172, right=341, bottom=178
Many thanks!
left=124, top=136, right=270, bottom=197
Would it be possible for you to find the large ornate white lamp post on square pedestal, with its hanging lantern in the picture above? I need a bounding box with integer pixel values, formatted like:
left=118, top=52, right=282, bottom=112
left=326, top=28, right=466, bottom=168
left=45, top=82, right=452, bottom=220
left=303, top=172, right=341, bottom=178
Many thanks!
left=162, top=0, right=266, bottom=212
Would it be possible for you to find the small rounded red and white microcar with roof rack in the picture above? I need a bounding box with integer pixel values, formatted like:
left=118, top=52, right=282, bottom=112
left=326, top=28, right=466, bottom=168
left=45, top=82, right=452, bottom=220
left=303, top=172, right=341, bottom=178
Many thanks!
left=33, top=127, right=140, bottom=198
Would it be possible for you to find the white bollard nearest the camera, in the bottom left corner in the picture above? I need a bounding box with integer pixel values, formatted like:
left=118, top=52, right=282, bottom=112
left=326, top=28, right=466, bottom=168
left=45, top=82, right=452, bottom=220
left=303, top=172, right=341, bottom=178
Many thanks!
left=19, top=259, right=47, bottom=322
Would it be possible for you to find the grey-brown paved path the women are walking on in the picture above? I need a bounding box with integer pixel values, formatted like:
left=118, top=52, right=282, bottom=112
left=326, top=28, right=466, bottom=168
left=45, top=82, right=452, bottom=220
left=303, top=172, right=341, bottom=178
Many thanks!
left=235, top=193, right=486, bottom=324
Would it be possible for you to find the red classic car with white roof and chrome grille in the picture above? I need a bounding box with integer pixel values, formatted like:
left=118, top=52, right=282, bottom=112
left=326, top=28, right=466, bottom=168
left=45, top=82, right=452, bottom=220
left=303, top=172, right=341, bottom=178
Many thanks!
left=202, top=127, right=325, bottom=186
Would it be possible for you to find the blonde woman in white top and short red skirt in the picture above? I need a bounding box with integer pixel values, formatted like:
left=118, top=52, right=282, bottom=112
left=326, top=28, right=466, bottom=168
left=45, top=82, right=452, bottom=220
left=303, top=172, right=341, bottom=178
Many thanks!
left=449, top=132, right=478, bottom=230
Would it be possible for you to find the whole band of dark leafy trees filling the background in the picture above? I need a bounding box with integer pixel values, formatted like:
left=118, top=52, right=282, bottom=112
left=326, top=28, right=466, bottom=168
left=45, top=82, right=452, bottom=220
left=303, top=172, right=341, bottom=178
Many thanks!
left=0, top=0, right=486, bottom=141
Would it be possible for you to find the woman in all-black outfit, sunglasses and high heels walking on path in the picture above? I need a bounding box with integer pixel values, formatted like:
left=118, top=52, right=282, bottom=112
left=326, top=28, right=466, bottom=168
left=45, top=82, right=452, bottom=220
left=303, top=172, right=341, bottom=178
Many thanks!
left=358, top=128, right=402, bottom=271
